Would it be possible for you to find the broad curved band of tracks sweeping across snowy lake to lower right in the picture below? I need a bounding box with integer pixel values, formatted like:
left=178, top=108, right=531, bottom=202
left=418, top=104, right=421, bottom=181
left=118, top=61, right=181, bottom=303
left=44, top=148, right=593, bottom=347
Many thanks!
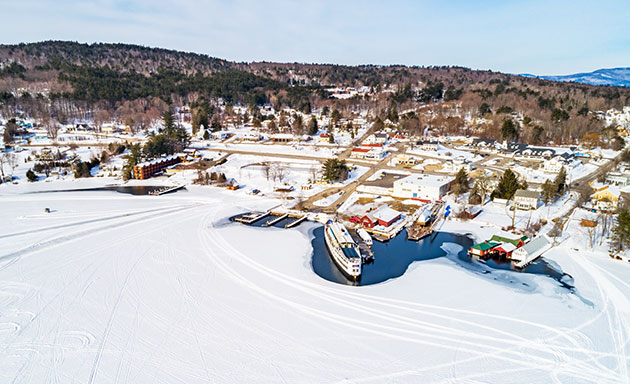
left=199, top=210, right=628, bottom=382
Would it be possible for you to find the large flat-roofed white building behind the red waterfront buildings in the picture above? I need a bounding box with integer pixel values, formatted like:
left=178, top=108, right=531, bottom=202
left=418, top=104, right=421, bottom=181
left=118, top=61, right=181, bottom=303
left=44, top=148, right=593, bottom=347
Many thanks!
left=393, top=174, right=455, bottom=201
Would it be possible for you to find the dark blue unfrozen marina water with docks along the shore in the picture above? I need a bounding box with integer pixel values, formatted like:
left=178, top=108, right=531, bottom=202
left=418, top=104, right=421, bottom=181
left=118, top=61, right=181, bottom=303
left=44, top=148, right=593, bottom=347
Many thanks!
left=230, top=213, right=573, bottom=292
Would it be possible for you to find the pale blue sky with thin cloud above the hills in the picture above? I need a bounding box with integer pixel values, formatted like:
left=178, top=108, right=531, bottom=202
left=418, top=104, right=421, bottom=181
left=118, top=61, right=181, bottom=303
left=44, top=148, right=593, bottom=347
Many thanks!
left=0, top=0, right=630, bottom=75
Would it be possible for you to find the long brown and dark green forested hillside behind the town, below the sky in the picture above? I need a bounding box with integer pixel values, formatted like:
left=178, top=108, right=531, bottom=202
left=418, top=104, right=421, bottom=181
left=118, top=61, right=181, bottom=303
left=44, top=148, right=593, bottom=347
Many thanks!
left=0, top=41, right=630, bottom=144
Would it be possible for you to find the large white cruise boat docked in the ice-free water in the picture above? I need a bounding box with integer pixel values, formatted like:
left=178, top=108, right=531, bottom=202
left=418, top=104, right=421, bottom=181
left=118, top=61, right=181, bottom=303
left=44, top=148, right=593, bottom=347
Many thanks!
left=324, top=220, right=361, bottom=280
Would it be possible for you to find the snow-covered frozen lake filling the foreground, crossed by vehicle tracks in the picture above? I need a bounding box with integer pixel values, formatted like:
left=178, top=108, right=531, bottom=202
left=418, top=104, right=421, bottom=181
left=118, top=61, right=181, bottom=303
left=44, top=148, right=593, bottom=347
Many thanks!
left=0, top=182, right=630, bottom=383
